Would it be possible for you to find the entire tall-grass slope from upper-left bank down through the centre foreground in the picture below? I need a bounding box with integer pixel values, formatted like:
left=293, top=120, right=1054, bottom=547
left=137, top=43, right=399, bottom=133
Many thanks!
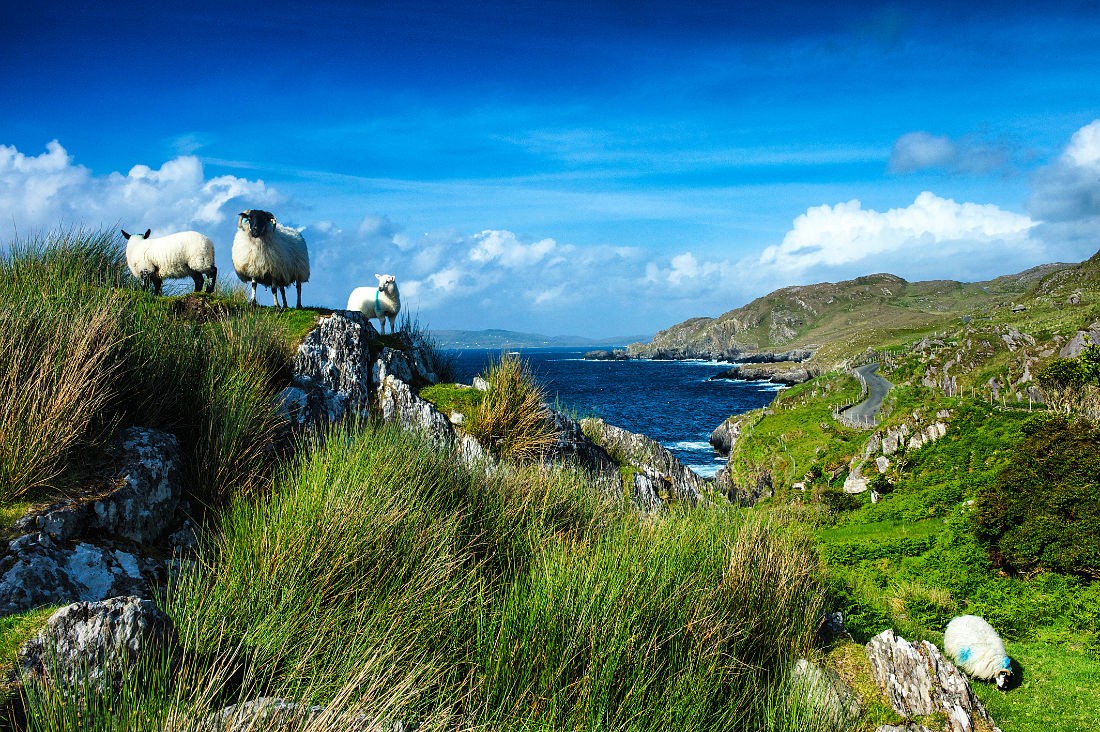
left=0, top=232, right=824, bottom=732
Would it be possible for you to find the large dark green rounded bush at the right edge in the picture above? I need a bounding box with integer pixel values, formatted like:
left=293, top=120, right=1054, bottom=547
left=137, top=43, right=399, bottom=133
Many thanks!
left=975, top=416, right=1100, bottom=577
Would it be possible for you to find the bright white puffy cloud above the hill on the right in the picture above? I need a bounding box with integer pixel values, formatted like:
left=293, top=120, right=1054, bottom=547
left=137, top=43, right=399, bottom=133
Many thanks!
left=758, top=192, right=1041, bottom=284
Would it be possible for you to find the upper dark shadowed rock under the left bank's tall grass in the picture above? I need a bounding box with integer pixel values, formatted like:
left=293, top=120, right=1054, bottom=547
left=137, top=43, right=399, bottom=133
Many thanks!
left=14, top=427, right=183, bottom=544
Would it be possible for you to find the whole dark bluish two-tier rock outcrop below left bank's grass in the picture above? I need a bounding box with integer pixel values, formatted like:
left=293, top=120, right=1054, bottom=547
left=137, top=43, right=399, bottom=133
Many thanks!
left=0, top=427, right=183, bottom=614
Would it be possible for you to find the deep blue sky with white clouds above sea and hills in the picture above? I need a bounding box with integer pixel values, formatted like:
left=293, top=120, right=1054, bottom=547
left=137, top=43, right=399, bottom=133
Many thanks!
left=0, top=0, right=1100, bottom=336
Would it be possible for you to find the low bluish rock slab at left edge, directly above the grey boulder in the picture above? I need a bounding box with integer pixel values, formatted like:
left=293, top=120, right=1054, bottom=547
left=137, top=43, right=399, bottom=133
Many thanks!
left=0, top=534, right=158, bottom=615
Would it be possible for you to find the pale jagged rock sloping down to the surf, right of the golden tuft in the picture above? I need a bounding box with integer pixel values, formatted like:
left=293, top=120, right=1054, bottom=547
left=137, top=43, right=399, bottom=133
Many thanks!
left=581, top=418, right=706, bottom=509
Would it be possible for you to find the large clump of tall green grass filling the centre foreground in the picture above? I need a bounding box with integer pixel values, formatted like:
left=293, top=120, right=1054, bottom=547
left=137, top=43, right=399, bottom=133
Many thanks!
left=107, top=426, right=821, bottom=730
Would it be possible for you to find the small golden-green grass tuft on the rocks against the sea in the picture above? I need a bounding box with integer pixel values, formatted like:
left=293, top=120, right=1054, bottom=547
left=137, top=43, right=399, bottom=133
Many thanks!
left=463, top=353, right=556, bottom=461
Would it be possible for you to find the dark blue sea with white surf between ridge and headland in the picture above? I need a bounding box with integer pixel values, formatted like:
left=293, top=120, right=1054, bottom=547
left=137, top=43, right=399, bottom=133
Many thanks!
left=452, top=348, right=778, bottom=477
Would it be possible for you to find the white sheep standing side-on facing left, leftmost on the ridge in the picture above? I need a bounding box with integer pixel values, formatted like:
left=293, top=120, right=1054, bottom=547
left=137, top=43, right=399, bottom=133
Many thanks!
left=122, top=229, right=218, bottom=295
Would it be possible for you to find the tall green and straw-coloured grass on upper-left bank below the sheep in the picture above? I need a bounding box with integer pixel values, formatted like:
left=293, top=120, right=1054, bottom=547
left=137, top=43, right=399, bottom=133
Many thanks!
left=0, top=230, right=290, bottom=504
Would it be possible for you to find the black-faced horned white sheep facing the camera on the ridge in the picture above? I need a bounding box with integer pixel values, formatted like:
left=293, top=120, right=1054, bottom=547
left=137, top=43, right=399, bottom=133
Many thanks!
left=233, top=209, right=309, bottom=307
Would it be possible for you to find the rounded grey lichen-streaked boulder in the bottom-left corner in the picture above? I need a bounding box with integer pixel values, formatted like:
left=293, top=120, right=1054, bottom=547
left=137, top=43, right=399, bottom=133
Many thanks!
left=19, top=597, right=178, bottom=691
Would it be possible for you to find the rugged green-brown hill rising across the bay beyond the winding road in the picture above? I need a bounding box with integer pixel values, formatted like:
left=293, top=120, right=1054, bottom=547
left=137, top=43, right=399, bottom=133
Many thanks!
left=628, top=256, right=1100, bottom=369
